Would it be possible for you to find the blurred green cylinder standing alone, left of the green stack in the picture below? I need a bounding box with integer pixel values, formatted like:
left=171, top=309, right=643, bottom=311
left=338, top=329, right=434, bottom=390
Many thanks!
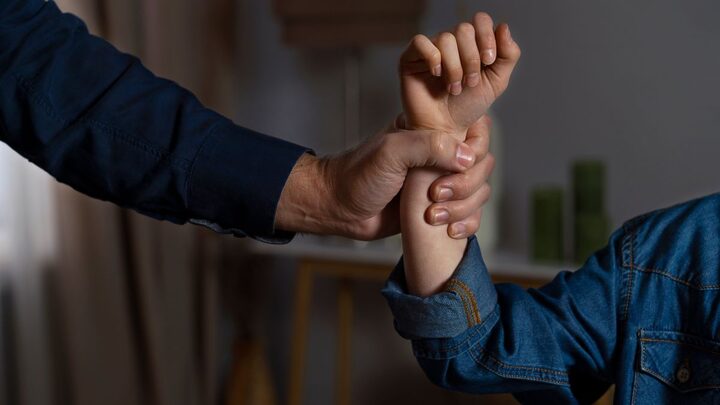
left=531, top=186, right=565, bottom=262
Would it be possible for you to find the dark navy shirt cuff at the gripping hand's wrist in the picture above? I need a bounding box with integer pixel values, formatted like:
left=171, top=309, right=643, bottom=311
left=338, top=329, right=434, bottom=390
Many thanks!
left=188, top=122, right=312, bottom=243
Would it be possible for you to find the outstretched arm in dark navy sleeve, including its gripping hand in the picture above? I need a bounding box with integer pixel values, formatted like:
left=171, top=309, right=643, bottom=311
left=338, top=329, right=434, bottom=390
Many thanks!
left=0, top=0, right=496, bottom=242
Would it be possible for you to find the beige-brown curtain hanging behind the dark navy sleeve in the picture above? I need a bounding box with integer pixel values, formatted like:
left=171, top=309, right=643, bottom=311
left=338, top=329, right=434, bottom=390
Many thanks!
left=48, top=0, right=239, bottom=405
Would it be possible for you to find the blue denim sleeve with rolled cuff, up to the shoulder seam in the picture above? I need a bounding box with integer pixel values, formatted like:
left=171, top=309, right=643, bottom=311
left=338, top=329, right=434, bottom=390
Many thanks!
left=383, top=232, right=622, bottom=403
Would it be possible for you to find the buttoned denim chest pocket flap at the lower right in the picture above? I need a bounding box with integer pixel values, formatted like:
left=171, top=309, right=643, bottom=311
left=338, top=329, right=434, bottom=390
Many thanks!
left=640, top=330, right=720, bottom=392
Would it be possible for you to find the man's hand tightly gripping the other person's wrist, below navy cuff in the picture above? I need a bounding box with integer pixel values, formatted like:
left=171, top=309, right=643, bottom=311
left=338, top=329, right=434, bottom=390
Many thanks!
left=276, top=119, right=493, bottom=240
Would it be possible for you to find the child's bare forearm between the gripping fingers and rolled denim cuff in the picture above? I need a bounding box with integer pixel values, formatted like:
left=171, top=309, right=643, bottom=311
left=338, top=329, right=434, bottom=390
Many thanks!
left=400, top=168, right=467, bottom=296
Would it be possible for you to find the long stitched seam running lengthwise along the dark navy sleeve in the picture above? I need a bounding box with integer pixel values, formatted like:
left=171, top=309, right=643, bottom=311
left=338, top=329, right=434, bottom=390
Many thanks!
left=14, top=75, right=190, bottom=170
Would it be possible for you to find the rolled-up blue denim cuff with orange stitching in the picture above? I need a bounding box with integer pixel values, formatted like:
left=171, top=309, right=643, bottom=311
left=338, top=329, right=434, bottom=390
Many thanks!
left=382, top=236, right=497, bottom=340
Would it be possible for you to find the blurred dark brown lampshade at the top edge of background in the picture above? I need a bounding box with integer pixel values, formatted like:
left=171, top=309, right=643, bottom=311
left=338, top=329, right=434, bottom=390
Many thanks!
left=275, top=0, right=425, bottom=47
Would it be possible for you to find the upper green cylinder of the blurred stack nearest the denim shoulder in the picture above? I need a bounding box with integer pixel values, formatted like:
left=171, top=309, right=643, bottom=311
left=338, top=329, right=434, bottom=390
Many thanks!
left=572, top=160, right=605, bottom=215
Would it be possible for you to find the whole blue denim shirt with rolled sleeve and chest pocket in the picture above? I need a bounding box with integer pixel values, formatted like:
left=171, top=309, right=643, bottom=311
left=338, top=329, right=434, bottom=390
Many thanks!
left=383, top=194, right=720, bottom=404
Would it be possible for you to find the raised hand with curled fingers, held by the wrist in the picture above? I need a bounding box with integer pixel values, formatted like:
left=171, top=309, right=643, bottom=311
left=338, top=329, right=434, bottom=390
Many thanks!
left=400, top=13, right=520, bottom=133
